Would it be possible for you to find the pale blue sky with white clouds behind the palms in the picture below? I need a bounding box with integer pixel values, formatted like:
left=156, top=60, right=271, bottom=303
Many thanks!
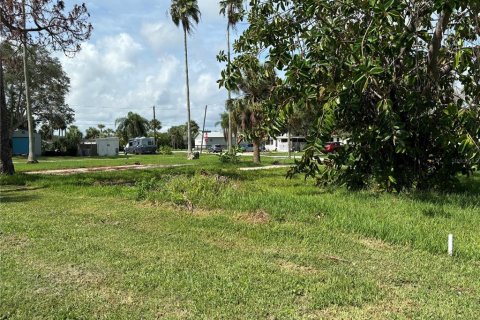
left=60, top=0, right=248, bottom=131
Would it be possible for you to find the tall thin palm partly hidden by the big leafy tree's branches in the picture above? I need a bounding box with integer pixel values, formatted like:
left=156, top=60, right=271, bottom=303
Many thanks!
left=220, top=0, right=244, bottom=152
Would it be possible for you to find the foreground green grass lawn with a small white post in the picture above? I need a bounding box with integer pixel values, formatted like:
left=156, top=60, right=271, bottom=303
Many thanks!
left=0, top=156, right=480, bottom=319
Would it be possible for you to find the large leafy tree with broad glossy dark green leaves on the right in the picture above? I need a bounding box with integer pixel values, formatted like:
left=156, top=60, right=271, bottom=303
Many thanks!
left=230, top=0, right=480, bottom=191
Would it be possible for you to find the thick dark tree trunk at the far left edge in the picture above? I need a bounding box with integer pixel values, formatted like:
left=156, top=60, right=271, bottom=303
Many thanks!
left=0, top=50, right=15, bottom=175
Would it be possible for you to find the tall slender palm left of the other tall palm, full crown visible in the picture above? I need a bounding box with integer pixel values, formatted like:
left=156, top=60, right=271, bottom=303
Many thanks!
left=170, top=0, right=201, bottom=158
